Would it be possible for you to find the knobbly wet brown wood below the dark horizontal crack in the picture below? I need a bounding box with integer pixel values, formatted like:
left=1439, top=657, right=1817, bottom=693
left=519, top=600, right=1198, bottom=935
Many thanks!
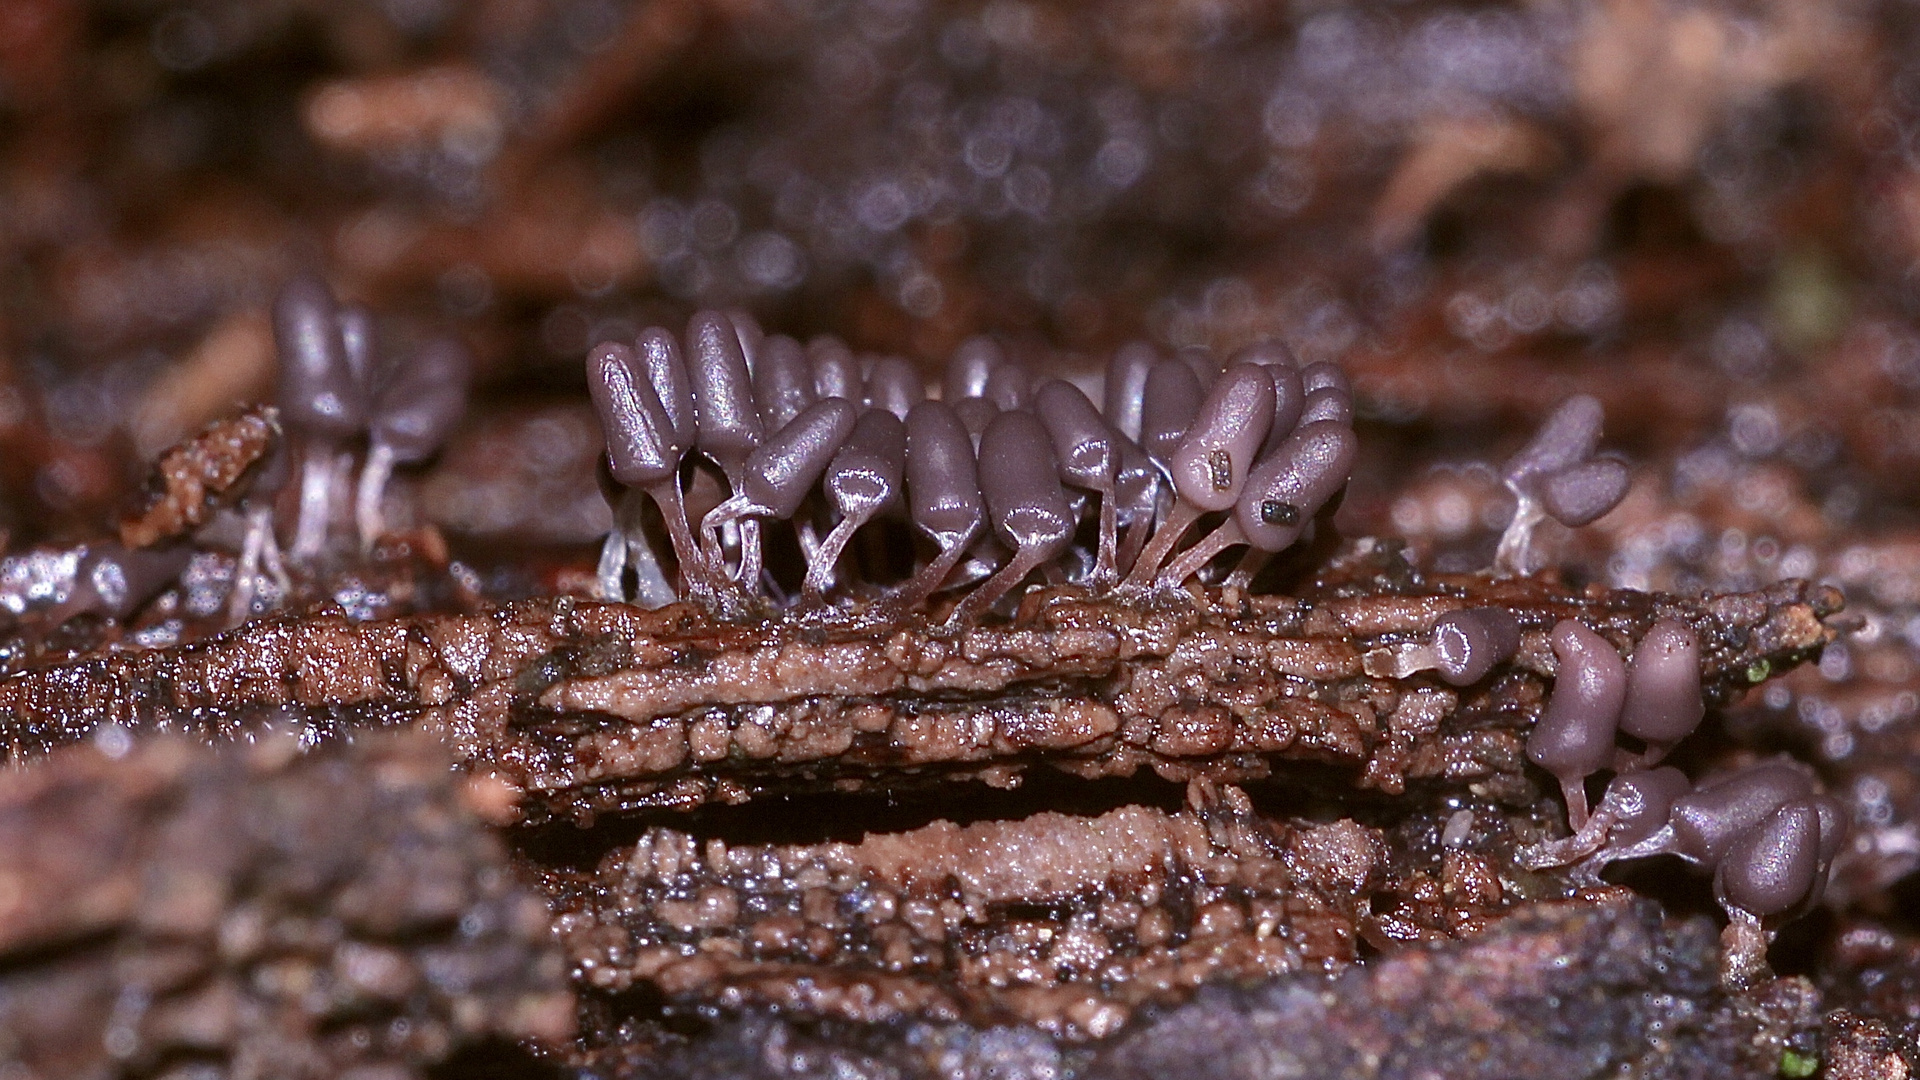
left=543, top=782, right=1565, bottom=1040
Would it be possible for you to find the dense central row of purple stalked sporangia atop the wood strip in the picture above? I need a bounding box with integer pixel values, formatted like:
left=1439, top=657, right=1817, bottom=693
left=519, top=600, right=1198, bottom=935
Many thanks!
left=588, top=311, right=1357, bottom=623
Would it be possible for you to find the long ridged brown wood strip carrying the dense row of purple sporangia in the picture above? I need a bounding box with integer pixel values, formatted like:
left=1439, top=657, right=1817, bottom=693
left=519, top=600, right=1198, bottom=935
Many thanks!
left=0, top=546, right=1839, bottom=821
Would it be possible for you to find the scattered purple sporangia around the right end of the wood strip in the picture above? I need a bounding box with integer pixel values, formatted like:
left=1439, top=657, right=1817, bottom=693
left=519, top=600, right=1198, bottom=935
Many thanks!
left=1443, top=396, right=1847, bottom=941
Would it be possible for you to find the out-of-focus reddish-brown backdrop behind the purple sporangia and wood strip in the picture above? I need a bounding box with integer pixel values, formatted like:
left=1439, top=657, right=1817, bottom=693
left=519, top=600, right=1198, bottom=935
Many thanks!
left=18, top=0, right=1920, bottom=995
